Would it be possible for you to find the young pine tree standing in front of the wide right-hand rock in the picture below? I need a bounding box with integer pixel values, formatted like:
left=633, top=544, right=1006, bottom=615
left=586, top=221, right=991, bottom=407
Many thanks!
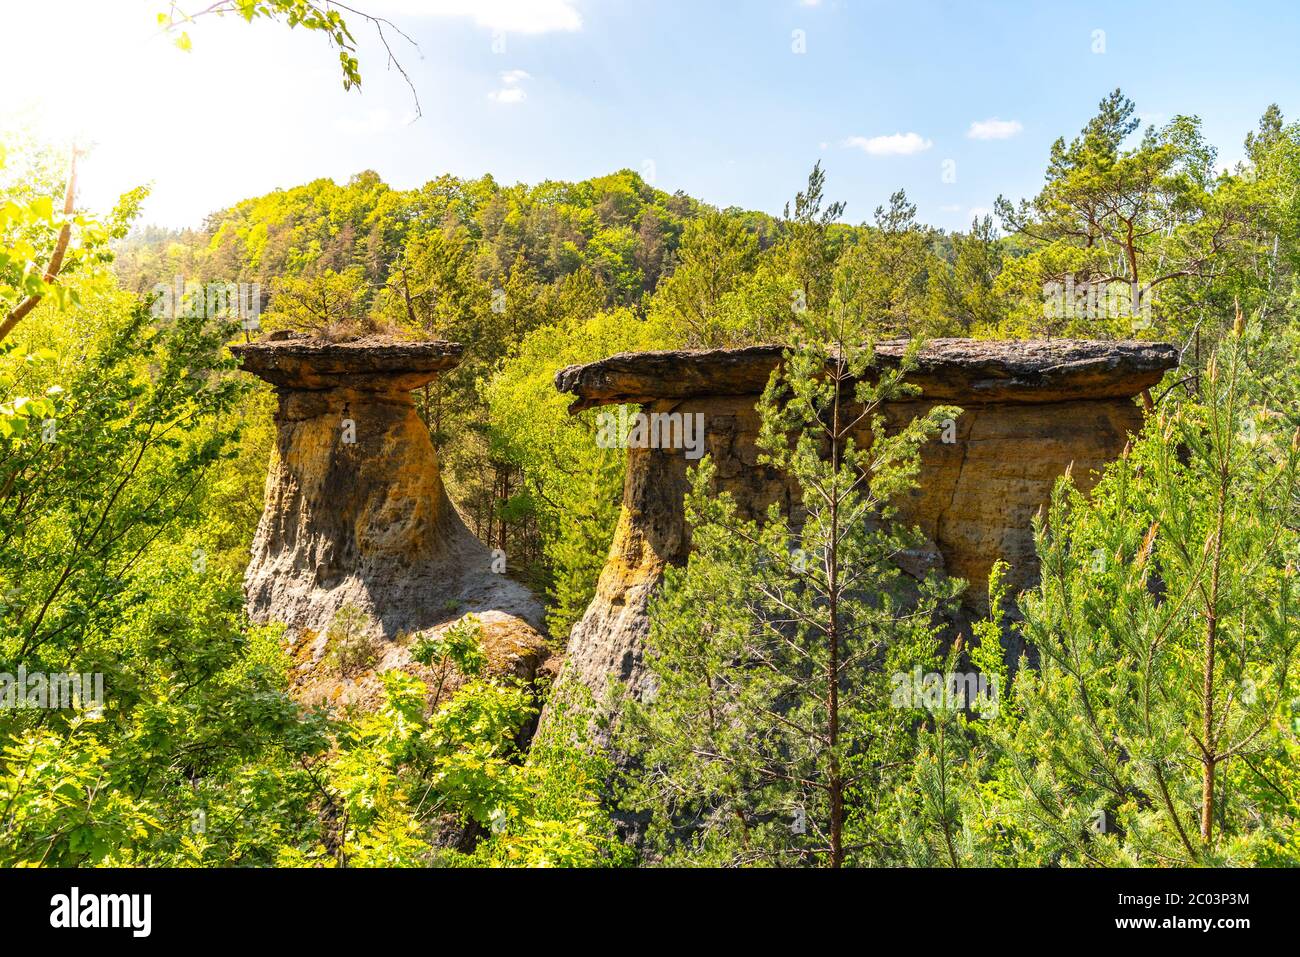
left=624, top=270, right=958, bottom=867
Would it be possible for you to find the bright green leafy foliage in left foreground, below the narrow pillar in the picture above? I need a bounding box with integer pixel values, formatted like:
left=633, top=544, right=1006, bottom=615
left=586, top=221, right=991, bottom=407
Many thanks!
left=0, top=273, right=618, bottom=865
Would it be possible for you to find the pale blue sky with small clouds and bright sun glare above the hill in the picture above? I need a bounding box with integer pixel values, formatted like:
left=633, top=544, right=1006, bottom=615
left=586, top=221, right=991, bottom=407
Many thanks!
left=0, top=0, right=1300, bottom=228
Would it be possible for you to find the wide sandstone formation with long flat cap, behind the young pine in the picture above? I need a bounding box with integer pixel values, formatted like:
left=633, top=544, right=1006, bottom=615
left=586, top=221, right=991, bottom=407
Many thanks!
left=555, top=339, right=1178, bottom=712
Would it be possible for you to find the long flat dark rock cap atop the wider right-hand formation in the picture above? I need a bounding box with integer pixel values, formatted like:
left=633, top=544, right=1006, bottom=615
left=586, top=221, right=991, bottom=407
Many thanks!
left=555, top=339, right=1179, bottom=412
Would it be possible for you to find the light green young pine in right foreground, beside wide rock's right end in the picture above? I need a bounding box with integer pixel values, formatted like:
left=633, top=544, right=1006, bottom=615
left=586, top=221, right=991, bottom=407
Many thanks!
left=972, top=317, right=1300, bottom=866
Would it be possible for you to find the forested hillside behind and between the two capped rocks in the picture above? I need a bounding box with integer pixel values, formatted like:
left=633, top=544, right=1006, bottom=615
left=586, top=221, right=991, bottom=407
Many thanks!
left=116, top=91, right=1297, bottom=647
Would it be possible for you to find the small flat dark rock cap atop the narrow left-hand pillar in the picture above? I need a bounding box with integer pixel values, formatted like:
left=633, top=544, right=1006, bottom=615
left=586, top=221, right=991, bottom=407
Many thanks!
left=230, top=332, right=464, bottom=391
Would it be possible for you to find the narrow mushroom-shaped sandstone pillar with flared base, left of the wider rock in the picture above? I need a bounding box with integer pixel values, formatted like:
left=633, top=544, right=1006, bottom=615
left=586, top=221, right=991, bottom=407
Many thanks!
left=231, top=333, right=542, bottom=647
